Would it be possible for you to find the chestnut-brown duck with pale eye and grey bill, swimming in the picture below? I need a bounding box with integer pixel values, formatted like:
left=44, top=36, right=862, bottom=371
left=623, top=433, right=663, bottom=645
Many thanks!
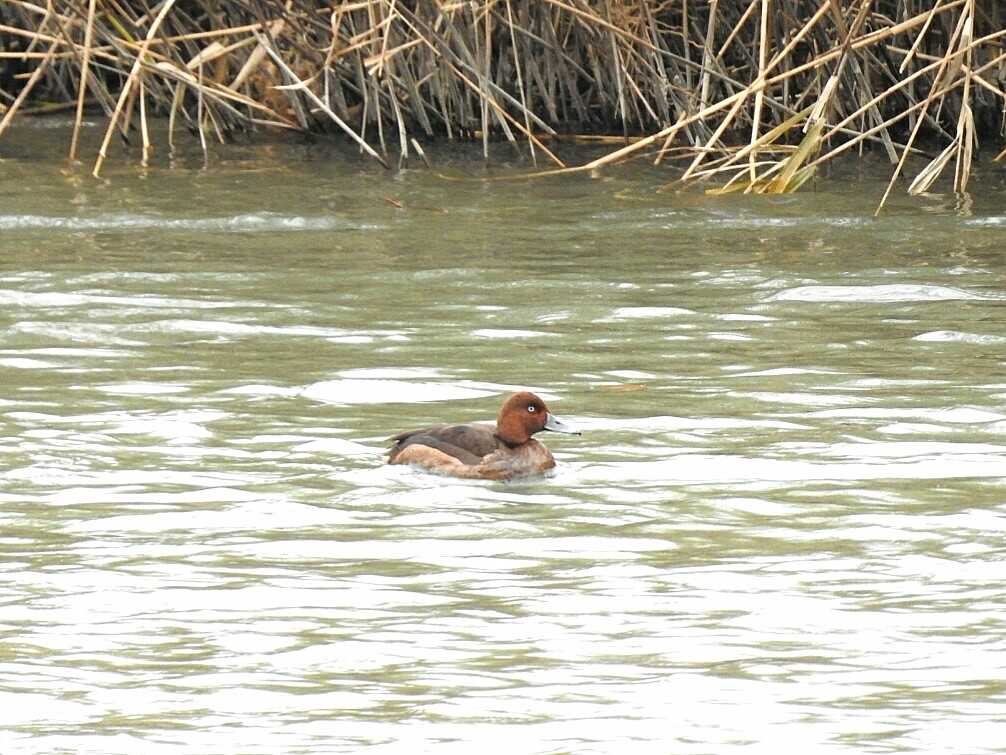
left=387, top=391, right=579, bottom=480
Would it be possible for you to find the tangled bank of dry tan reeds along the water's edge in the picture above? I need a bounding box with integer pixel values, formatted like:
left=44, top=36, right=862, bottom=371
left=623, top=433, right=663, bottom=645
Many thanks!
left=0, top=0, right=1006, bottom=209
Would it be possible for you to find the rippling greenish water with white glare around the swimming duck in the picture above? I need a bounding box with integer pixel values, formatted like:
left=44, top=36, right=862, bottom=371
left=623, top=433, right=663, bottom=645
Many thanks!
left=0, top=121, right=1006, bottom=755
